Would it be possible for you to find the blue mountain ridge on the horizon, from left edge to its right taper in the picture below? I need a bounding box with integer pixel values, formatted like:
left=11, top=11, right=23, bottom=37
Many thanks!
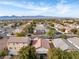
left=0, top=15, right=52, bottom=20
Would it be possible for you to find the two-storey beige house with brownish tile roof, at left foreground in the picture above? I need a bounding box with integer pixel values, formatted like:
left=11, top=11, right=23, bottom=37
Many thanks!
left=7, top=37, right=30, bottom=55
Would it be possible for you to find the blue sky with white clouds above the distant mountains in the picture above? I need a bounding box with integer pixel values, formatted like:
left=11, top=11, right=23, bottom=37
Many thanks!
left=0, top=0, right=79, bottom=17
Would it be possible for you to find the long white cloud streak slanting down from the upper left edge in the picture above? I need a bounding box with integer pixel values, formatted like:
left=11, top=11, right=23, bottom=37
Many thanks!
left=0, top=1, right=49, bottom=11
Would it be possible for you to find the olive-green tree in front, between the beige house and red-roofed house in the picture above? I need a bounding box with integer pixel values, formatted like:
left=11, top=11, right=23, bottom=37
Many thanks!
left=19, top=46, right=36, bottom=59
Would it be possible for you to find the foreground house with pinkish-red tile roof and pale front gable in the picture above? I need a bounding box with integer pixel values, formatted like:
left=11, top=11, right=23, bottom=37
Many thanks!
left=33, top=38, right=51, bottom=59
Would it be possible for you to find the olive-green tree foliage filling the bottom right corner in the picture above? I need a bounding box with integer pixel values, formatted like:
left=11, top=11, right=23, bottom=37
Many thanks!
left=48, top=48, right=79, bottom=59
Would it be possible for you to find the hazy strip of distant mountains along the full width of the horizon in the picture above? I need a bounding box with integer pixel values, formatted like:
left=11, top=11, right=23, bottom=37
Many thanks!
left=0, top=15, right=79, bottom=20
